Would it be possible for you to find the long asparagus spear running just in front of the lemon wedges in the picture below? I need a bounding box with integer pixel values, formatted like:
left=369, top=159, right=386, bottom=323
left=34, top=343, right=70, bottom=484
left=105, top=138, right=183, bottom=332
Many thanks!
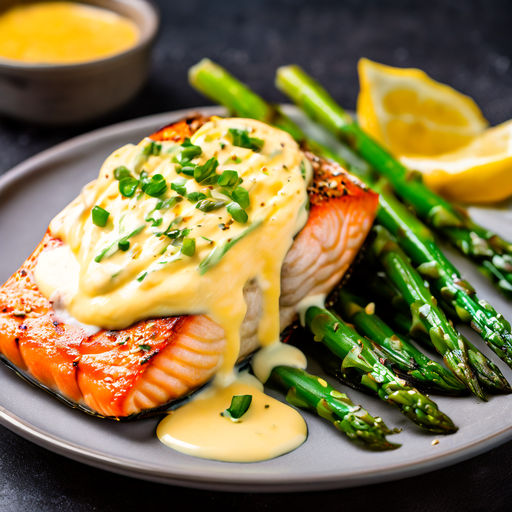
left=276, top=66, right=512, bottom=293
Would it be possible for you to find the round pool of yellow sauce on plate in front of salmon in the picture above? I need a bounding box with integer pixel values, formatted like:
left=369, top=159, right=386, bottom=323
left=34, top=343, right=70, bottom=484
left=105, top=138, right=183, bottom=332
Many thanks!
left=157, top=379, right=307, bottom=462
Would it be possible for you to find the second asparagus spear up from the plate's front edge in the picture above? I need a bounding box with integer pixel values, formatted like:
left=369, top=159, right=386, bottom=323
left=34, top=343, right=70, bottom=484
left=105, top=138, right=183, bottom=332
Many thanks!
left=305, top=306, right=457, bottom=434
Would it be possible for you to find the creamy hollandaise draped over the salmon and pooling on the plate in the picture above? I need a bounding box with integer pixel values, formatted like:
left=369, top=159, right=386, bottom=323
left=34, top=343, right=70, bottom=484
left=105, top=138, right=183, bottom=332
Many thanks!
left=34, top=118, right=311, bottom=461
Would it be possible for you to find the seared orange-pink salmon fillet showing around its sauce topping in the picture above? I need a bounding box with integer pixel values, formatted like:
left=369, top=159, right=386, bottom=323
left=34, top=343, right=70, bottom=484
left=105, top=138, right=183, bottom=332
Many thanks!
left=0, top=116, right=378, bottom=418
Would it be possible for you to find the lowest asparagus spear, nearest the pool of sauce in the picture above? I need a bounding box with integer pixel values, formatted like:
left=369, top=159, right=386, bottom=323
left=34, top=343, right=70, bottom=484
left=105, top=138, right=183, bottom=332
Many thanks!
left=269, top=366, right=400, bottom=451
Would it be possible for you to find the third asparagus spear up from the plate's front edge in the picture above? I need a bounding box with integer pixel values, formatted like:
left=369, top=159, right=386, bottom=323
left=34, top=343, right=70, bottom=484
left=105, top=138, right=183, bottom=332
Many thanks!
left=336, top=289, right=465, bottom=394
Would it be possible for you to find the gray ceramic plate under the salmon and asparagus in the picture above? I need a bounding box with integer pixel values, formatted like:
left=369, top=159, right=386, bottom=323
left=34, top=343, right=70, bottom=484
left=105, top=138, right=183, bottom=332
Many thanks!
left=0, top=108, right=512, bottom=491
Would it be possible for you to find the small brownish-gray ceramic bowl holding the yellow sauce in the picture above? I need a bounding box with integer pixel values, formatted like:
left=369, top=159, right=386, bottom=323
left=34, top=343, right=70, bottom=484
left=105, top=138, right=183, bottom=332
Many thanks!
left=0, top=0, right=158, bottom=125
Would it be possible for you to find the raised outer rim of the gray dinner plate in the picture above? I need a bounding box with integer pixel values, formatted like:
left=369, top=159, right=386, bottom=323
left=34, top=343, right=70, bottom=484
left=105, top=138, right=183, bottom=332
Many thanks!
left=0, top=105, right=512, bottom=492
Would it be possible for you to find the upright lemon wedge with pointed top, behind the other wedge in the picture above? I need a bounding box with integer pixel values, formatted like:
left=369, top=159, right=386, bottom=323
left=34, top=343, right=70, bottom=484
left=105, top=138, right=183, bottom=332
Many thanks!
left=357, top=59, right=488, bottom=156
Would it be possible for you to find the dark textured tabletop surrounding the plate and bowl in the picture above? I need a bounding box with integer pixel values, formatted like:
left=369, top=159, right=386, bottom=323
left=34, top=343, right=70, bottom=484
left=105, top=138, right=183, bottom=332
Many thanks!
left=0, top=0, right=512, bottom=512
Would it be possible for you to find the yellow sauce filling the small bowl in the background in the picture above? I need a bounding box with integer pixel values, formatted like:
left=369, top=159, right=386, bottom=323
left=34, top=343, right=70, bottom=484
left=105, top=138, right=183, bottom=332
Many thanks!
left=0, top=2, right=139, bottom=64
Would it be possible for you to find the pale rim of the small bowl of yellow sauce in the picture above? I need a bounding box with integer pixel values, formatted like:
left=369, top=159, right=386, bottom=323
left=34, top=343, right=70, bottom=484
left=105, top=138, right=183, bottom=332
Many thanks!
left=0, top=0, right=160, bottom=72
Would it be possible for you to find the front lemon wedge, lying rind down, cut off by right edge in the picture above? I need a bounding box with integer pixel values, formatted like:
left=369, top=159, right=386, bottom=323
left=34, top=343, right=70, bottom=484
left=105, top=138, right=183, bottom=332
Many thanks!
left=400, top=120, right=512, bottom=203
